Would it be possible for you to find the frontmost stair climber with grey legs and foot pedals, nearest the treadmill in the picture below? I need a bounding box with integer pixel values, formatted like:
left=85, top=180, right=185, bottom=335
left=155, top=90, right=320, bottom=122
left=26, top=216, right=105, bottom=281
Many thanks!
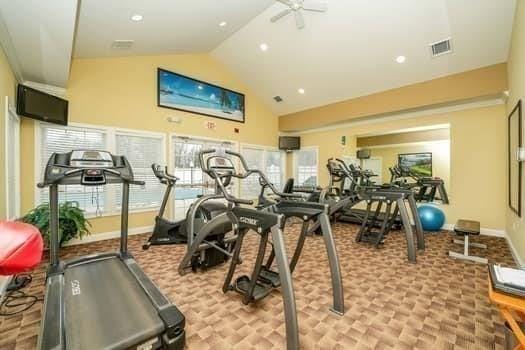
left=178, top=149, right=299, bottom=350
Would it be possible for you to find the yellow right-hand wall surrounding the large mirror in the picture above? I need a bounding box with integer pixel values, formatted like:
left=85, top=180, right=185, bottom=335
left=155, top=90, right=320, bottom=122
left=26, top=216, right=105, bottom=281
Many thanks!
left=288, top=105, right=506, bottom=230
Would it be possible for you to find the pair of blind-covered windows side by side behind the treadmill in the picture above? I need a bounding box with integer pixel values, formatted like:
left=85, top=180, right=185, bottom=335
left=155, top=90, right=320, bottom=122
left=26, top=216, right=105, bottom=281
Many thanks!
left=36, top=123, right=165, bottom=215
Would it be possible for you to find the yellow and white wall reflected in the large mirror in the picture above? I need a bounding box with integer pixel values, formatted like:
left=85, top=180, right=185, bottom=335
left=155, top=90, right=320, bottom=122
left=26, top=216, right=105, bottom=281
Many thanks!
left=364, top=140, right=452, bottom=191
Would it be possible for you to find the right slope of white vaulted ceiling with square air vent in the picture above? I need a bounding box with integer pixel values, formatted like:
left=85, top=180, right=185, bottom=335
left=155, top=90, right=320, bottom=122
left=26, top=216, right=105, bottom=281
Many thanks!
left=212, top=0, right=515, bottom=115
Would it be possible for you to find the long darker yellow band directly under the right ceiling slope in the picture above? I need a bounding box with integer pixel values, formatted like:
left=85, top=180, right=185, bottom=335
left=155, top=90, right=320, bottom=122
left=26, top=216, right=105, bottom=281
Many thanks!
left=279, top=63, right=507, bottom=132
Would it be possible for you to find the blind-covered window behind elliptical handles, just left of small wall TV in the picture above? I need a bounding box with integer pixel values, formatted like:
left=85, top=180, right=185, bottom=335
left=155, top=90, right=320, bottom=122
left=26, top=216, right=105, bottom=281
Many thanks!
left=241, top=146, right=284, bottom=198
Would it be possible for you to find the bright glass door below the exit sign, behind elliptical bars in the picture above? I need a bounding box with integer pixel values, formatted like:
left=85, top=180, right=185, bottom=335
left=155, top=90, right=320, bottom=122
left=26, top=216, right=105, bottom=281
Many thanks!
left=172, top=136, right=234, bottom=220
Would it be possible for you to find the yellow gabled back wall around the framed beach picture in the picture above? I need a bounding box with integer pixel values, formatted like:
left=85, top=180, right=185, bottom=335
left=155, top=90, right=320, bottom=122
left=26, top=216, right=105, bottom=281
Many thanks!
left=21, top=55, right=278, bottom=232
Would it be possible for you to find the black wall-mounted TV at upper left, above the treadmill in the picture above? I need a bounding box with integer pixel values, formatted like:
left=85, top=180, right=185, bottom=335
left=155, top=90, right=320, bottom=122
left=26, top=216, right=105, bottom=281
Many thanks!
left=16, top=85, right=68, bottom=125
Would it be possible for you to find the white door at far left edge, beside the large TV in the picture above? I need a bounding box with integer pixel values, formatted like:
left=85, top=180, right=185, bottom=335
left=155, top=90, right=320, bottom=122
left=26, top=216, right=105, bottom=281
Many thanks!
left=5, top=96, right=20, bottom=220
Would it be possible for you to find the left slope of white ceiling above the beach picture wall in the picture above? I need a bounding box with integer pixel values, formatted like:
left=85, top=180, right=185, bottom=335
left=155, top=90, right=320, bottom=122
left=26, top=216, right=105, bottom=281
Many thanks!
left=75, top=0, right=273, bottom=57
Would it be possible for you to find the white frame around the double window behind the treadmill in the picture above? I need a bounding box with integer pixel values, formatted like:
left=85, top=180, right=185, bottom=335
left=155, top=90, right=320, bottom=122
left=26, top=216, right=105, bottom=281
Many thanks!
left=33, top=121, right=168, bottom=219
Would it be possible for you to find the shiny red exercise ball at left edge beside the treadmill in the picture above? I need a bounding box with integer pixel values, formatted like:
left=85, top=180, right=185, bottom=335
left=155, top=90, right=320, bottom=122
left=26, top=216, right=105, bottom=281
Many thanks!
left=0, top=221, right=44, bottom=275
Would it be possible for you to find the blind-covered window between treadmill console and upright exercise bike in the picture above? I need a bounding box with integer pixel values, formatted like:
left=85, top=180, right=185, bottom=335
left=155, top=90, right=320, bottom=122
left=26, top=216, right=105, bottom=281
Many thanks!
left=115, top=133, right=165, bottom=209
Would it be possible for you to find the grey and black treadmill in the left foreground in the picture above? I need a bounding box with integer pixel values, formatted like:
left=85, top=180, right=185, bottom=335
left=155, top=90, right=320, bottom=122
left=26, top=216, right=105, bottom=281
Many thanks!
left=38, top=150, right=185, bottom=350
